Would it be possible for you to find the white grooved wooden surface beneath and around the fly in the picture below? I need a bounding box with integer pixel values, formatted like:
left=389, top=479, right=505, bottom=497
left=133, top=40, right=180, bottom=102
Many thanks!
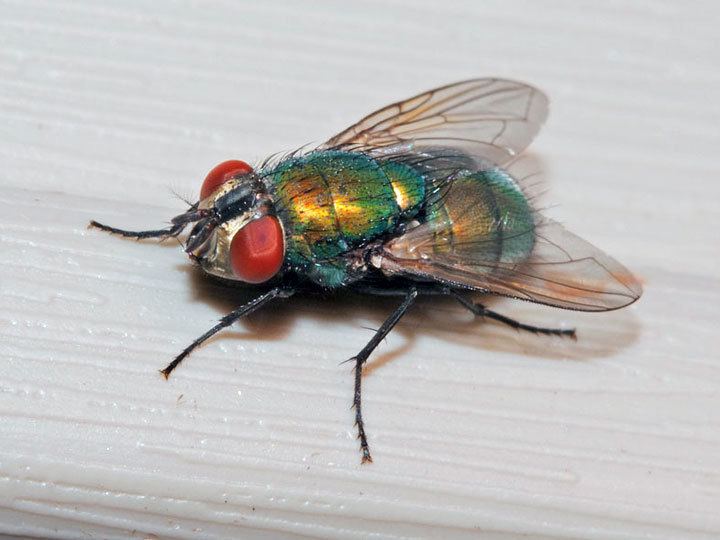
left=0, top=0, right=720, bottom=540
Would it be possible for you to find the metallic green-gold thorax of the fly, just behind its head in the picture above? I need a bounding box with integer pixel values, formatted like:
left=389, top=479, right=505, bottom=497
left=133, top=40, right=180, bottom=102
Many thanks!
left=269, top=151, right=425, bottom=285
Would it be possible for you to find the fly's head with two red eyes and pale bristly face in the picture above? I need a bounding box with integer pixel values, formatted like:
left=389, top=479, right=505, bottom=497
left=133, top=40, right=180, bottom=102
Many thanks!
left=173, top=161, right=285, bottom=283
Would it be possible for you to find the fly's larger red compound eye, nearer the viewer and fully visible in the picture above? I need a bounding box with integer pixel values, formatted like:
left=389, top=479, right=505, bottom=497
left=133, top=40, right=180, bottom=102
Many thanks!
left=230, top=216, right=285, bottom=283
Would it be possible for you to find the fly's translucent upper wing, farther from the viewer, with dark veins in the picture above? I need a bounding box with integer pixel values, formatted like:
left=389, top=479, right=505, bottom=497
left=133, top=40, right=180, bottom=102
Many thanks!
left=323, top=78, right=548, bottom=165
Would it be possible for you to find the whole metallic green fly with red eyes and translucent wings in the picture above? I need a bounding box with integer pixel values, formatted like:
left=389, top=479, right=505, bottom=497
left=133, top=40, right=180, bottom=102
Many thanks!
left=90, top=78, right=642, bottom=463
